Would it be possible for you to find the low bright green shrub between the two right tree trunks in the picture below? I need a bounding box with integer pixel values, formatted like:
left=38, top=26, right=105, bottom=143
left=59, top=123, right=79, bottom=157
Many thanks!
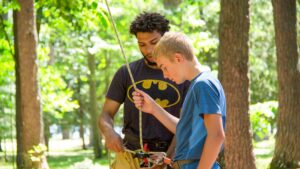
left=250, top=101, right=278, bottom=141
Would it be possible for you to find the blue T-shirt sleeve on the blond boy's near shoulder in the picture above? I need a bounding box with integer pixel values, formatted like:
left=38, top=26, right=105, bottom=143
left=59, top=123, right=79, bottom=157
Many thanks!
left=194, top=81, right=222, bottom=116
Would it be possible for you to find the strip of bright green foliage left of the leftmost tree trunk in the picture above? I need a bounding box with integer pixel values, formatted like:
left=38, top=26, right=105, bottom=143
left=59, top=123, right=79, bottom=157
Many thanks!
left=0, top=10, right=15, bottom=139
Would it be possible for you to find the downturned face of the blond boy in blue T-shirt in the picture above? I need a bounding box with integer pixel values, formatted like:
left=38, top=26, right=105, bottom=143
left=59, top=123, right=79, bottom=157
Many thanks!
left=156, top=56, right=185, bottom=84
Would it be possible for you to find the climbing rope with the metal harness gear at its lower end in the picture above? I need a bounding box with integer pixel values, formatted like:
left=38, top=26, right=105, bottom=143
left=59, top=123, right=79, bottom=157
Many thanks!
left=105, top=0, right=170, bottom=167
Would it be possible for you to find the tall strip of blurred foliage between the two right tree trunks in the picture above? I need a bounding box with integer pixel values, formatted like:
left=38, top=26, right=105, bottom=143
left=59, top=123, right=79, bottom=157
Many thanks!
left=249, top=0, right=278, bottom=104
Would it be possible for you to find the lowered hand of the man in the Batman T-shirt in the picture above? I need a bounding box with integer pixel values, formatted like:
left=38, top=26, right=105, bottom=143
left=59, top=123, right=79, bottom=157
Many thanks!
left=105, top=131, right=124, bottom=152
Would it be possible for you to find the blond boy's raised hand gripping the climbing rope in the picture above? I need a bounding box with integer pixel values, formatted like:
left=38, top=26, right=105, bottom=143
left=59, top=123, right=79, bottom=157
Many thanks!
left=132, top=89, right=158, bottom=114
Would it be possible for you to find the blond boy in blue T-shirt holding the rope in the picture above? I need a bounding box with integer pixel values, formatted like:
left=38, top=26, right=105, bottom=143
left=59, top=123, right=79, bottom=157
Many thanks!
left=133, top=32, right=226, bottom=169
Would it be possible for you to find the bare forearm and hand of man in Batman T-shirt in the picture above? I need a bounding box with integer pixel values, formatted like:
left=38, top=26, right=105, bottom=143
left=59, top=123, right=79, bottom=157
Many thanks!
left=98, top=98, right=123, bottom=152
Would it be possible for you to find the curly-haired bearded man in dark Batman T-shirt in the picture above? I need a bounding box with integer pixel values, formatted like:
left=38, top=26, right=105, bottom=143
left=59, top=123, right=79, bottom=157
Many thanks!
left=99, top=13, right=188, bottom=169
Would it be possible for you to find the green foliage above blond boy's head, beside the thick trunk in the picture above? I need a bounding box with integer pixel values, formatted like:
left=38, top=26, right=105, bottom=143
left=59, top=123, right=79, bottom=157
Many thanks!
left=166, top=0, right=220, bottom=70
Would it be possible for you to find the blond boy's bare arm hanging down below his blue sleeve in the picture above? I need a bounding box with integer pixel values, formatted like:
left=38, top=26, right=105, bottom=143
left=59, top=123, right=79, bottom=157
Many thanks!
left=197, top=114, right=225, bottom=169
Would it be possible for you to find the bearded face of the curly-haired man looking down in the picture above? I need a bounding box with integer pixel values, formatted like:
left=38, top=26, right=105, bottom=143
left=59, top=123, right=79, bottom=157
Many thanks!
left=136, top=31, right=161, bottom=66
